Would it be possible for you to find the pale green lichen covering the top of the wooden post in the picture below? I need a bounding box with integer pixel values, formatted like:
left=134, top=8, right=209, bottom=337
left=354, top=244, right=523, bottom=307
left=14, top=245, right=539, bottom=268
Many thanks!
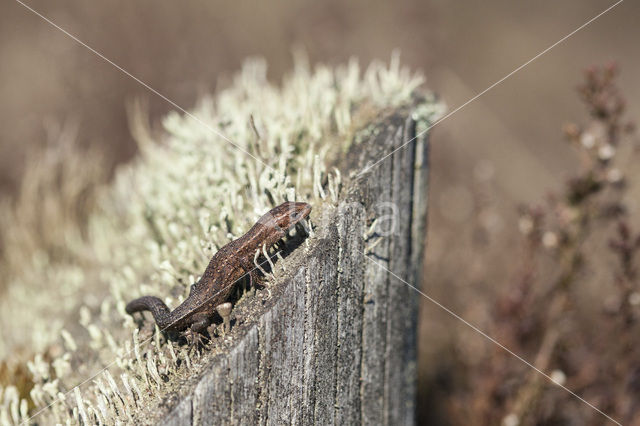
left=0, top=56, right=442, bottom=424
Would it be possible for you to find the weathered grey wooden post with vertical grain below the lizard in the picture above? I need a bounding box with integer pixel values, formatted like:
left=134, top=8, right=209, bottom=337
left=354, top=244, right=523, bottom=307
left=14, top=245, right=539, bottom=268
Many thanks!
left=162, top=110, right=428, bottom=425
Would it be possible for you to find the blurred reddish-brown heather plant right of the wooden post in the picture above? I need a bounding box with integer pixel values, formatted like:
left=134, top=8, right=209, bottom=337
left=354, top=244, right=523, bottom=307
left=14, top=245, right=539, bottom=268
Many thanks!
left=448, top=64, right=640, bottom=426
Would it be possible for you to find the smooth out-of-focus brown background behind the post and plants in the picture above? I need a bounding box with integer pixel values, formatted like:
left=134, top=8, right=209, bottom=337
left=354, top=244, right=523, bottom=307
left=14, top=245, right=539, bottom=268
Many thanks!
left=0, top=0, right=640, bottom=422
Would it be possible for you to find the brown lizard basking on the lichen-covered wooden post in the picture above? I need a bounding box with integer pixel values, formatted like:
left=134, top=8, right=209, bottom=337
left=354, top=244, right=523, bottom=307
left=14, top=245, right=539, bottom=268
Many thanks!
left=125, top=201, right=311, bottom=337
